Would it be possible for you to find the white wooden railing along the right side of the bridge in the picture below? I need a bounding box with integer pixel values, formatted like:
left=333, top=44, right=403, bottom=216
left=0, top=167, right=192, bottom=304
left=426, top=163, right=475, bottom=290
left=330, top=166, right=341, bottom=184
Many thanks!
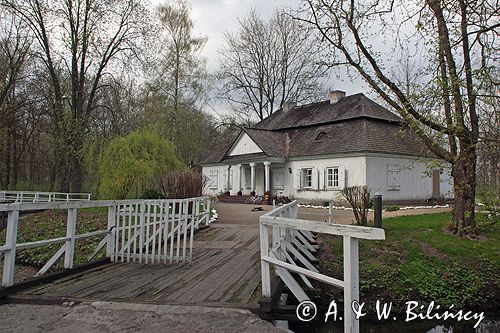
left=260, top=201, right=385, bottom=333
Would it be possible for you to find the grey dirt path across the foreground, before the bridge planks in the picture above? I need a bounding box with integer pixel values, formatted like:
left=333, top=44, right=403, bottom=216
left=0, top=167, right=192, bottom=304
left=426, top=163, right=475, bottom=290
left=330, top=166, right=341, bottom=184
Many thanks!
left=0, top=302, right=283, bottom=333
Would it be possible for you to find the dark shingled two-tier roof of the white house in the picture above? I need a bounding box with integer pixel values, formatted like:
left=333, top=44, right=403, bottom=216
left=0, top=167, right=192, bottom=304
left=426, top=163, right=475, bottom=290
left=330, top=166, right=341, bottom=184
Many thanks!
left=202, top=94, right=434, bottom=164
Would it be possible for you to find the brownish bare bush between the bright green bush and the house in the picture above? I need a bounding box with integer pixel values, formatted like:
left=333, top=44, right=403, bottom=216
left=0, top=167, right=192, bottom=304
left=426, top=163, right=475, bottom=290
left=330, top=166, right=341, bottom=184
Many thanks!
left=160, top=170, right=208, bottom=199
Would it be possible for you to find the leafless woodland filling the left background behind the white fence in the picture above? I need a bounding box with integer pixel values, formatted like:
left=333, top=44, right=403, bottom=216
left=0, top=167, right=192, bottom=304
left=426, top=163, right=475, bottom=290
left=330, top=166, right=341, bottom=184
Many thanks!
left=0, top=0, right=232, bottom=198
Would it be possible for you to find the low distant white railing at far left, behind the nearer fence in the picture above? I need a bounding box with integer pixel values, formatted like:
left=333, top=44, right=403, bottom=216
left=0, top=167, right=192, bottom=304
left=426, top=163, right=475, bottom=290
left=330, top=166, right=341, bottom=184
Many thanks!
left=0, top=191, right=92, bottom=204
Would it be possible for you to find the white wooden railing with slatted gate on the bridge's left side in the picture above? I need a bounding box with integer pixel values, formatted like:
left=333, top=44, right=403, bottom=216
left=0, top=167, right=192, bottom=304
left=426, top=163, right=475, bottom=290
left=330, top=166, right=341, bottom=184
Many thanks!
left=0, top=197, right=211, bottom=286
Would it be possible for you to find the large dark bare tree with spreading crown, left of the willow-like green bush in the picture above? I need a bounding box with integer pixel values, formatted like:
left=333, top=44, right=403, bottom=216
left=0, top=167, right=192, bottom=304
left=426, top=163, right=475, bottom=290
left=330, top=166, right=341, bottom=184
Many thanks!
left=0, top=0, right=147, bottom=191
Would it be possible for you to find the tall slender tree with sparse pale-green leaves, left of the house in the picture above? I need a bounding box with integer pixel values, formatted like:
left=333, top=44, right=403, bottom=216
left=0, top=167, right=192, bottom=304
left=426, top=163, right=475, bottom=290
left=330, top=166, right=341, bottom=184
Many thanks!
left=143, top=0, right=211, bottom=165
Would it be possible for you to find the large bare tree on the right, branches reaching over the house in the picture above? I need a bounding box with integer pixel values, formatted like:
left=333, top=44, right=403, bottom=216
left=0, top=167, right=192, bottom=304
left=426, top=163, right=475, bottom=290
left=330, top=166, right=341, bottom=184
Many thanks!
left=300, top=0, right=500, bottom=236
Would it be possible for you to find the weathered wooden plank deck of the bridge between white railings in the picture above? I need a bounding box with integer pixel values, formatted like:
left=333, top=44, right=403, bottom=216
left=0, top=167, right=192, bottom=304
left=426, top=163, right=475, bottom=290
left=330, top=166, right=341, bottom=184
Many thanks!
left=14, top=224, right=260, bottom=305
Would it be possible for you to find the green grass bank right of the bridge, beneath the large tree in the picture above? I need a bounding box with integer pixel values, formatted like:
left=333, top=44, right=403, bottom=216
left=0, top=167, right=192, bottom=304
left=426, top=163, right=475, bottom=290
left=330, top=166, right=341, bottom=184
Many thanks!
left=320, top=213, right=500, bottom=310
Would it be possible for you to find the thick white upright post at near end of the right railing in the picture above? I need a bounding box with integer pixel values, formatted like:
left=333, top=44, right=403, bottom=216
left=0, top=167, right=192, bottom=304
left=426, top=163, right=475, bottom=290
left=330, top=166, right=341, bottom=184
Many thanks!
left=343, top=236, right=359, bottom=333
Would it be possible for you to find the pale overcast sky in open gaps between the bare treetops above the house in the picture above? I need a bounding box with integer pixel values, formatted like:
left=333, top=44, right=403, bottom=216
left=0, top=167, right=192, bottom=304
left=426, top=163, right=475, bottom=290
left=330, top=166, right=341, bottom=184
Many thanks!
left=148, top=0, right=369, bottom=111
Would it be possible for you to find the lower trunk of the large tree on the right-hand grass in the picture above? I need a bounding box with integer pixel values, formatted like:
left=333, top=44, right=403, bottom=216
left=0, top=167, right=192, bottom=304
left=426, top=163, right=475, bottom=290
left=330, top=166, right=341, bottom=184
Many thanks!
left=451, top=148, right=476, bottom=237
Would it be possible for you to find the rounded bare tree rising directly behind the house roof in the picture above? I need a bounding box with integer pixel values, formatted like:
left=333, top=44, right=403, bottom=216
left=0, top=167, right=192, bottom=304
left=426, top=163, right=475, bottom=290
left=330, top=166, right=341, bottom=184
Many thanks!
left=218, top=10, right=325, bottom=120
